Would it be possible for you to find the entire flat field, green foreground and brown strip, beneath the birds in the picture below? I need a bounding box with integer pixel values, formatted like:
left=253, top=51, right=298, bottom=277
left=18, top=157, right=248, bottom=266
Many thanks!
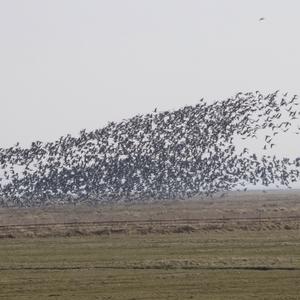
left=0, top=192, right=300, bottom=300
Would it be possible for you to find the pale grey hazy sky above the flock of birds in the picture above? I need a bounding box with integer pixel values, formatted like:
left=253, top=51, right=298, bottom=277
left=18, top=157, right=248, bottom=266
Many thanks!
left=0, top=0, right=300, bottom=149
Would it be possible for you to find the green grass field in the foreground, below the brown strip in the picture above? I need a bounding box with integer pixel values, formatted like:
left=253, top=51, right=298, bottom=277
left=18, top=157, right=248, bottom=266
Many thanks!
left=0, top=230, right=300, bottom=300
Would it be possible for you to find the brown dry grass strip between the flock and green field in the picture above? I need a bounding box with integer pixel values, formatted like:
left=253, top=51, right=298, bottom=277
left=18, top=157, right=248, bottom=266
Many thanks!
left=0, top=191, right=300, bottom=238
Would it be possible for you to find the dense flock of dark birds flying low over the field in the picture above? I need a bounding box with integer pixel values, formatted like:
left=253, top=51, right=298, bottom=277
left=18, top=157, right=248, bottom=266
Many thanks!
left=0, top=91, right=300, bottom=207
